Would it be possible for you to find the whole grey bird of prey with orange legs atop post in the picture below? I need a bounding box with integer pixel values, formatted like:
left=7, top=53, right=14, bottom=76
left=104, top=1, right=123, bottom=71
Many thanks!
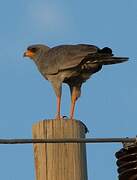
left=24, top=44, right=128, bottom=119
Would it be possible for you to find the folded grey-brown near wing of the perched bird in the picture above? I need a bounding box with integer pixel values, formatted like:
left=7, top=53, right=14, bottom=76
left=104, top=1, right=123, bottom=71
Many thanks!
left=41, top=44, right=98, bottom=74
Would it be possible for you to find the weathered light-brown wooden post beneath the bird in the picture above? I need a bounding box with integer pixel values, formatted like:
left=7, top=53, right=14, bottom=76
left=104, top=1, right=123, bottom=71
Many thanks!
left=32, top=119, right=87, bottom=180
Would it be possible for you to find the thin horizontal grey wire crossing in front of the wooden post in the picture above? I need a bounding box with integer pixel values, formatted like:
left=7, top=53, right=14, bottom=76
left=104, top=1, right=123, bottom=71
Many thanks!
left=0, top=137, right=137, bottom=144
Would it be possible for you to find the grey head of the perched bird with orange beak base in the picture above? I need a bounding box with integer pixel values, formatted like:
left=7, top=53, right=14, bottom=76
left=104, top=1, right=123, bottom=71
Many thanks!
left=23, top=44, right=50, bottom=61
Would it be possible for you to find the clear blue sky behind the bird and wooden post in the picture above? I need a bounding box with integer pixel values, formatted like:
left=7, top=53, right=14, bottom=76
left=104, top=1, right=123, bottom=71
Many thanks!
left=0, top=0, right=137, bottom=180
